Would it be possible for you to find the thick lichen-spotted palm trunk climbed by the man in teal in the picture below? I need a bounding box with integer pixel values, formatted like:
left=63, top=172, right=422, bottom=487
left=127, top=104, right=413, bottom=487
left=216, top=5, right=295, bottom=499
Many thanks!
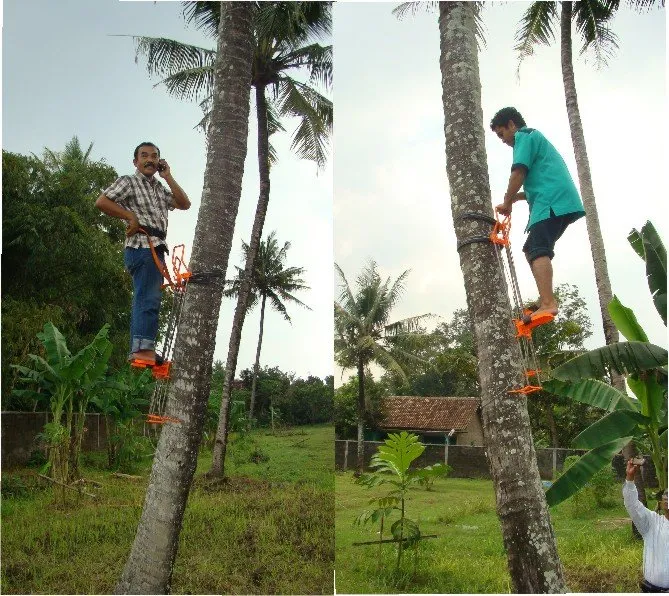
left=439, top=2, right=566, bottom=593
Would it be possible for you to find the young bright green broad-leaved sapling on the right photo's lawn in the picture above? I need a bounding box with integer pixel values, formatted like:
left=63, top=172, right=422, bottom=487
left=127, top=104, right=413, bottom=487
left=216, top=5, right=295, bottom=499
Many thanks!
left=353, top=432, right=447, bottom=570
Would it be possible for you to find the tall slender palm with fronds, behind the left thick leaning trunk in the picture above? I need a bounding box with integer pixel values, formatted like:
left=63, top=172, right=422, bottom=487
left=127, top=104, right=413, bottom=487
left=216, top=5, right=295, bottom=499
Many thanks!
left=125, top=2, right=332, bottom=475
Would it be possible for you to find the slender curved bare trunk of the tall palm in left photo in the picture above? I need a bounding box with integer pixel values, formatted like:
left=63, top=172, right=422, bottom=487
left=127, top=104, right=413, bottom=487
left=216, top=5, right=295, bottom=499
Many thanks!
left=209, top=85, right=270, bottom=476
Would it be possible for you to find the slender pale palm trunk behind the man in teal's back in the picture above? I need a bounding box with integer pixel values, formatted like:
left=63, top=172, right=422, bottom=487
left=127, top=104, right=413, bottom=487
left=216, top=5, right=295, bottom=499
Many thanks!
left=560, top=2, right=646, bottom=512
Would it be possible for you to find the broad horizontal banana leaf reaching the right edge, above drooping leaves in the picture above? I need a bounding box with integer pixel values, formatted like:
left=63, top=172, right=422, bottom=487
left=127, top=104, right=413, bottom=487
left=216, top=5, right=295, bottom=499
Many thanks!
left=551, top=341, right=667, bottom=381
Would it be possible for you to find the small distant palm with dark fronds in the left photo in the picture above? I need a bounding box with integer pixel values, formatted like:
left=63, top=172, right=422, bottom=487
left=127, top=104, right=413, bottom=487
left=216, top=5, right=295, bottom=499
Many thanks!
left=224, top=232, right=311, bottom=418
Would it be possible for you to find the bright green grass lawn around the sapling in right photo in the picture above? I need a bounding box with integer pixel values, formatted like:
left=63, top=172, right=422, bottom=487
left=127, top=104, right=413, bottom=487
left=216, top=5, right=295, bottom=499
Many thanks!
left=335, top=472, right=643, bottom=594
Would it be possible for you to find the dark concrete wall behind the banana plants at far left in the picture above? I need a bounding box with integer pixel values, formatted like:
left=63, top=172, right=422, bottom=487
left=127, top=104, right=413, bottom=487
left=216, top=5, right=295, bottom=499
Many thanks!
left=0, top=412, right=107, bottom=470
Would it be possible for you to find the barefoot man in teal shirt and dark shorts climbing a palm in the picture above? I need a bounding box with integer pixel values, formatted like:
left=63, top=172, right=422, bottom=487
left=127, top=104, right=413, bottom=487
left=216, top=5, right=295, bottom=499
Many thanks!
left=490, top=108, right=585, bottom=322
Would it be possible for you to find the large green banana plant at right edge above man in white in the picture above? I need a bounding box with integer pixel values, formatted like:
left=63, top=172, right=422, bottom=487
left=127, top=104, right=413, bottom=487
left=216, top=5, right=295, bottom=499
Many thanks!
left=544, top=222, right=667, bottom=506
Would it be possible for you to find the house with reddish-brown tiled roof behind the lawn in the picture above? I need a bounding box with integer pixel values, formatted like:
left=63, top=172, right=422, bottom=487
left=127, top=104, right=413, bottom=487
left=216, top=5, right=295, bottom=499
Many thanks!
left=380, top=396, right=483, bottom=445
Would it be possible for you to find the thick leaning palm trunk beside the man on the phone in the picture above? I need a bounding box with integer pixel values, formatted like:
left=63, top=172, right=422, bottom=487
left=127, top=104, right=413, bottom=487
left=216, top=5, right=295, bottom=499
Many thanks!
left=116, top=2, right=253, bottom=594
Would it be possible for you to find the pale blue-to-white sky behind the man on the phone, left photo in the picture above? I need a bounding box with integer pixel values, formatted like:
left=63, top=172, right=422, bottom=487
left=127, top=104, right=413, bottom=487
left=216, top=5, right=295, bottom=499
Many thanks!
left=2, top=0, right=333, bottom=378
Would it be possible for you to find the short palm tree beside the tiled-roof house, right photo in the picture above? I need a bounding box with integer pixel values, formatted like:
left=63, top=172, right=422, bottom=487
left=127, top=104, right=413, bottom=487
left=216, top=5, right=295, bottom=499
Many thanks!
left=334, top=261, right=422, bottom=473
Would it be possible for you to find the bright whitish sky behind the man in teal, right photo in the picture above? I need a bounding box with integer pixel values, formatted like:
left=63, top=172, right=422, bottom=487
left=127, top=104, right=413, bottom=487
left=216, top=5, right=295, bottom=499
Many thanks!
left=334, top=2, right=669, bottom=384
